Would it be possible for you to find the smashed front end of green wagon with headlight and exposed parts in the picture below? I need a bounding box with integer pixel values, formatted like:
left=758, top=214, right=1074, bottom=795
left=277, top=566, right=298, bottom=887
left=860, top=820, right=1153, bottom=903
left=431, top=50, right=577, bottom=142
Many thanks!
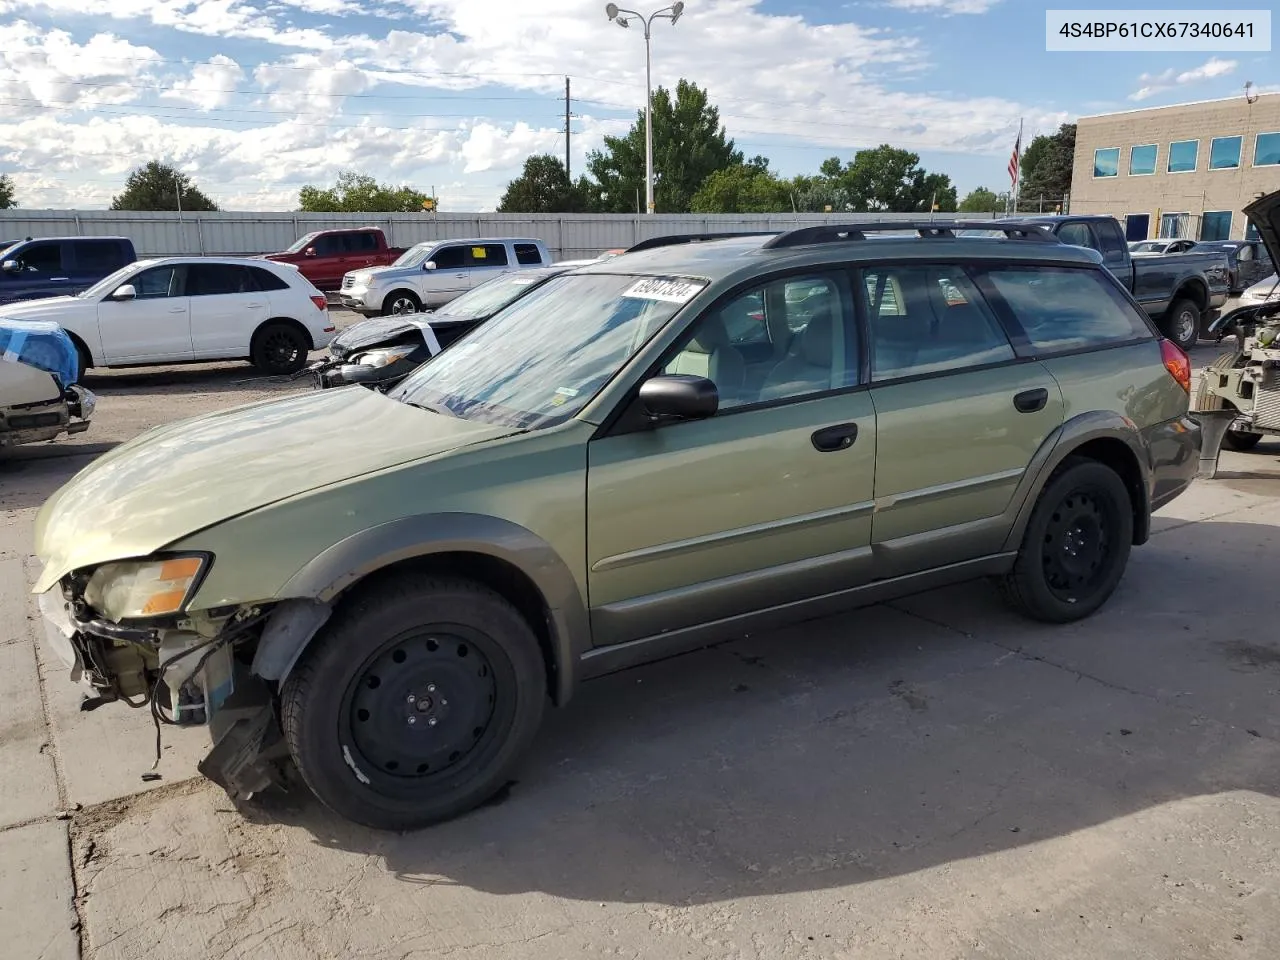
left=40, top=557, right=328, bottom=799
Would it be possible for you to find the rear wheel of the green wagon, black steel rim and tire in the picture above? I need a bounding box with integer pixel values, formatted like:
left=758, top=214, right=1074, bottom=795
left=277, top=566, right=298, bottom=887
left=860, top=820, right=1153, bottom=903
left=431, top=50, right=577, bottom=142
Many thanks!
left=1000, top=457, right=1133, bottom=623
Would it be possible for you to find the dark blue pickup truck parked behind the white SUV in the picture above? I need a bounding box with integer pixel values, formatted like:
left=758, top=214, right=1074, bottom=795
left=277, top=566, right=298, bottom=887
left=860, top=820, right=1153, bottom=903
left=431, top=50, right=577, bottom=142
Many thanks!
left=0, top=237, right=138, bottom=303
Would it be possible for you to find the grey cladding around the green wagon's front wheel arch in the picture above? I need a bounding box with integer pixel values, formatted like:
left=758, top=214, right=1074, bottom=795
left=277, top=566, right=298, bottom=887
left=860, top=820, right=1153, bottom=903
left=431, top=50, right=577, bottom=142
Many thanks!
left=261, top=513, right=590, bottom=704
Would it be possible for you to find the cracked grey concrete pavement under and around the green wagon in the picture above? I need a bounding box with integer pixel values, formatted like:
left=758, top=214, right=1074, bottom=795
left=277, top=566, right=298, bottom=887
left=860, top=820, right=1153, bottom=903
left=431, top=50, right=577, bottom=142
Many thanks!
left=0, top=330, right=1280, bottom=960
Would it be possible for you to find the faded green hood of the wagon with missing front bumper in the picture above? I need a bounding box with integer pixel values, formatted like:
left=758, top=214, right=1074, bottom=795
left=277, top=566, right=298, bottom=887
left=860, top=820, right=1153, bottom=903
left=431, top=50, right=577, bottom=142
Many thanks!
left=36, top=387, right=518, bottom=593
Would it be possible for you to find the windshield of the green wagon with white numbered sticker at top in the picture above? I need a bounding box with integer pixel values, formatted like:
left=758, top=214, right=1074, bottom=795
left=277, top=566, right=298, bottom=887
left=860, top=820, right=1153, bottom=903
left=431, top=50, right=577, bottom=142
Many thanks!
left=388, top=274, right=705, bottom=429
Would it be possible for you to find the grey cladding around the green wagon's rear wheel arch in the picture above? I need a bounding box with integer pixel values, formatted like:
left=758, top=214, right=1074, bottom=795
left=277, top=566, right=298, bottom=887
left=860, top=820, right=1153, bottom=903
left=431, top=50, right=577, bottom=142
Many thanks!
left=1005, top=411, right=1151, bottom=550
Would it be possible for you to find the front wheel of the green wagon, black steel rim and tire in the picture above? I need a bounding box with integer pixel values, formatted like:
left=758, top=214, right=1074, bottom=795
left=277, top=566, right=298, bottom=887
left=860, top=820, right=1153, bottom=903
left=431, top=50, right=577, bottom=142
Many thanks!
left=280, top=577, right=547, bottom=831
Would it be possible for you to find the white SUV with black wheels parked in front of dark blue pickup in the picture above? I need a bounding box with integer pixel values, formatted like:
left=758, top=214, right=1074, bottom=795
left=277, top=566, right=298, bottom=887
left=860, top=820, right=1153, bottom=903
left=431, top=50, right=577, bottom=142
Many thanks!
left=0, top=257, right=335, bottom=374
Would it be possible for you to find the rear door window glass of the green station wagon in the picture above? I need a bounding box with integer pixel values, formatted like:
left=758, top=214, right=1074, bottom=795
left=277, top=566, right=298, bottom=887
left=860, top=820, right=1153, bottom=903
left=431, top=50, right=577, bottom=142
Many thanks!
left=860, top=264, right=1015, bottom=381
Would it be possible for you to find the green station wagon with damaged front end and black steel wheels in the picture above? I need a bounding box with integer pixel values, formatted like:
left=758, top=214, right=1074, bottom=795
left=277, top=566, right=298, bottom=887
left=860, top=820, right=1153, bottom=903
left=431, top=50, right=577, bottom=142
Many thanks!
left=36, top=223, right=1201, bottom=829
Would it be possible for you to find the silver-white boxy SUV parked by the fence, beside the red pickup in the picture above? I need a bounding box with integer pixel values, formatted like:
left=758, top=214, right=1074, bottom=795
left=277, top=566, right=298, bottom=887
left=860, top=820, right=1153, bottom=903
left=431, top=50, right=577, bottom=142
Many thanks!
left=338, top=237, right=552, bottom=316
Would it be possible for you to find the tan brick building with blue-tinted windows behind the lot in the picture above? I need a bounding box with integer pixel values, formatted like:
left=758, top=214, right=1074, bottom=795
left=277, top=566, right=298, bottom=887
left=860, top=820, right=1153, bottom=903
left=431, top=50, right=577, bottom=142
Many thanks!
left=1070, top=93, right=1280, bottom=239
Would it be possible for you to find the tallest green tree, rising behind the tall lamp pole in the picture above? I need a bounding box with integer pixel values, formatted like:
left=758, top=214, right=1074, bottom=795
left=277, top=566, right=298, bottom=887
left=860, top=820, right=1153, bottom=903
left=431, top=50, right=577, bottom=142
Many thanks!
left=586, top=79, right=742, bottom=214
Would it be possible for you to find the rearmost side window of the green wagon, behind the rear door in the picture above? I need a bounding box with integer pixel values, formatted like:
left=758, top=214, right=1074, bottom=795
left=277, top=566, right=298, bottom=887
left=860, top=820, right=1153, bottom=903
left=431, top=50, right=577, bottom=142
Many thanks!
left=983, top=265, right=1153, bottom=356
